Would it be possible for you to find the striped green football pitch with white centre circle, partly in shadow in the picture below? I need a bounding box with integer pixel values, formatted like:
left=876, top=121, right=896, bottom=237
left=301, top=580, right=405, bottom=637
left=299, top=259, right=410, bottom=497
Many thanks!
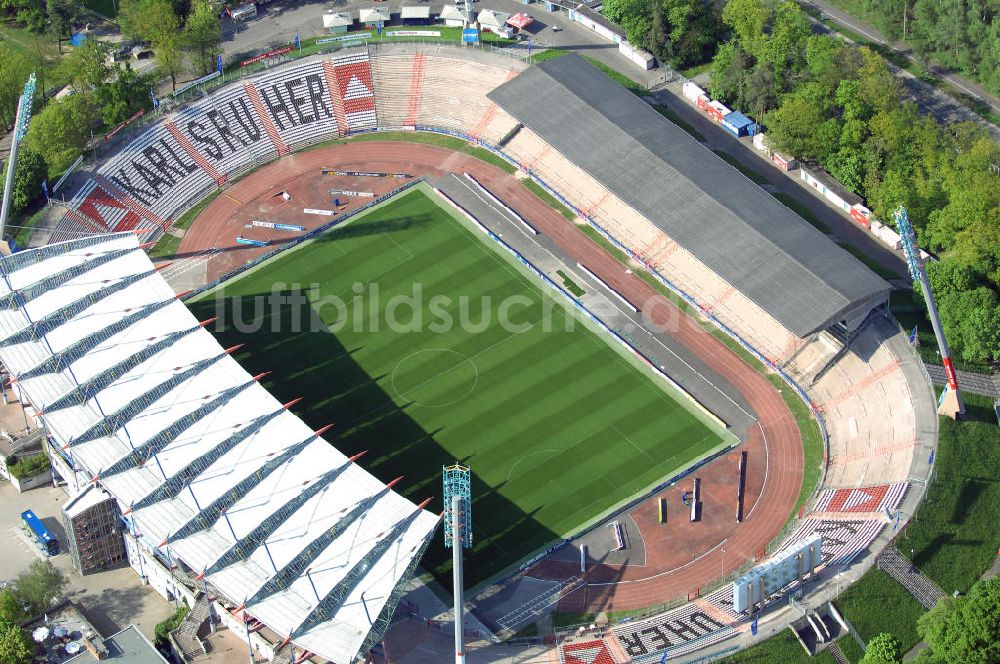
left=191, top=185, right=732, bottom=587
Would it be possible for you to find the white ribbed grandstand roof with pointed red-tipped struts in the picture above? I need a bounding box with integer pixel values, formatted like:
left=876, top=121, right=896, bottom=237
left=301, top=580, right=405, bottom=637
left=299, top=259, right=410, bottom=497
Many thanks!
left=0, top=233, right=438, bottom=662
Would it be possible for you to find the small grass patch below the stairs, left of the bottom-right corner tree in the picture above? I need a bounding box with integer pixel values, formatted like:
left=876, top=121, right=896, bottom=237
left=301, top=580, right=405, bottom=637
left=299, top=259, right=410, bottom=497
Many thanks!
left=834, top=568, right=924, bottom=652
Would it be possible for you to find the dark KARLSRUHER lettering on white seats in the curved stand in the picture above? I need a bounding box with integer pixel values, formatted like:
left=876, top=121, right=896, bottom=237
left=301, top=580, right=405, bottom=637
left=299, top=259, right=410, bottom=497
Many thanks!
left=87, top=68, right=333, bottom=225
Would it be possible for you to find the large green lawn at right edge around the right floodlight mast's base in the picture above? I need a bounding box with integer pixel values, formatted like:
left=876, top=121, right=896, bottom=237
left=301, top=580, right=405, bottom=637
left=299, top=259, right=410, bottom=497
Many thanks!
left=899, top=392, right=1000, bottom=593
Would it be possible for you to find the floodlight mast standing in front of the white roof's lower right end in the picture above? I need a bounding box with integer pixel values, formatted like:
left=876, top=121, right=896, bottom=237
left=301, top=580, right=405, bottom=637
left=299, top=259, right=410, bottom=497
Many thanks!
left=443, top=464, right=472, bottom=664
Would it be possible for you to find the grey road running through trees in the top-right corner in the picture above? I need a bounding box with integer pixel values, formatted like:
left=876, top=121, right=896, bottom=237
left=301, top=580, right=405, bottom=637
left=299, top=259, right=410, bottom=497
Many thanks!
left=796, top=0, right=1000, bottom=140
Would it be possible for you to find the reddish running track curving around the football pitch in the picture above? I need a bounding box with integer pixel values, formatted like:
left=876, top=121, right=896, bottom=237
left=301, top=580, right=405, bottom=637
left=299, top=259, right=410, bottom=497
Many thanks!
left=179, top=141, right=803, bottom=612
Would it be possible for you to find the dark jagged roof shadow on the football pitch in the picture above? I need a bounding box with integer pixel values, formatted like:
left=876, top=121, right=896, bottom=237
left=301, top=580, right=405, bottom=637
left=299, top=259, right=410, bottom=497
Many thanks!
left=189, top=284, right=556, bottom=588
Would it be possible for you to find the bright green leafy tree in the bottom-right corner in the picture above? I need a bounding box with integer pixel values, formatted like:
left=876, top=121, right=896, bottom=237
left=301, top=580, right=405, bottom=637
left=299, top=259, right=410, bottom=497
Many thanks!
left=917, top=577, right=1000, bottom=664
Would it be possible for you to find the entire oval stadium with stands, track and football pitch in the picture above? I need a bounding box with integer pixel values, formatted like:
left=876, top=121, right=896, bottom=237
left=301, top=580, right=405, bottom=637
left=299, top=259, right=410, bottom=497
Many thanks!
left=0, top=44, right=937, bottom=664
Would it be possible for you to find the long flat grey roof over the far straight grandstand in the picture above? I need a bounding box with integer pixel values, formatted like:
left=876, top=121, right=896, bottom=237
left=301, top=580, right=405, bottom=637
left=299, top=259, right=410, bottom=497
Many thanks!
left=489, top=55, right=890, bottom=337
